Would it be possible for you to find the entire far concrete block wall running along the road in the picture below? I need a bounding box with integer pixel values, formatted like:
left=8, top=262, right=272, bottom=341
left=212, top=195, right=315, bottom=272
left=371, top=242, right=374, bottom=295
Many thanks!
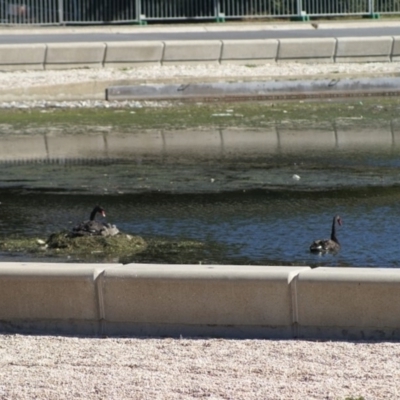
left=0, top=36, right=400, bottom=70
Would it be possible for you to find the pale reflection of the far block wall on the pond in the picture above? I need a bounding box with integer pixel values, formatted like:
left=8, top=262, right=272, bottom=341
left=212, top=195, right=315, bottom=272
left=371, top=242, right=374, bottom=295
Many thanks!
left=0, top=122, right=400, bottom=163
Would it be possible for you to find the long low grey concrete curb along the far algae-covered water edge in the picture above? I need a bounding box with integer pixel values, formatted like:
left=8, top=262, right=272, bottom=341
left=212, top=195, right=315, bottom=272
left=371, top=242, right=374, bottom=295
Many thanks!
left=106, top=77, right=400, bottom=100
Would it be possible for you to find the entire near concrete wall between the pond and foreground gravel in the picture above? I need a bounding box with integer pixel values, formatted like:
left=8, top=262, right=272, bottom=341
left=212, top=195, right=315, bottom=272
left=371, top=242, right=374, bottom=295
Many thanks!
left=0, top=263, right=400, bottom=340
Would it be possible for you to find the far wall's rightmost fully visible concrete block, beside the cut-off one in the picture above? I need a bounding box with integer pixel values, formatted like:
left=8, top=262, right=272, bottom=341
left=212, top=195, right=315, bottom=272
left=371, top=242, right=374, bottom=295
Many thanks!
left=335, top=36, right=393, bottom=62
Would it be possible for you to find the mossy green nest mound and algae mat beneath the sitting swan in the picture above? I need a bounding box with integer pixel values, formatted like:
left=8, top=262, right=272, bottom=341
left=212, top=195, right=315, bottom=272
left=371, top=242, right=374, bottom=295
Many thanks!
left=0, top=232, right=217, bottom=264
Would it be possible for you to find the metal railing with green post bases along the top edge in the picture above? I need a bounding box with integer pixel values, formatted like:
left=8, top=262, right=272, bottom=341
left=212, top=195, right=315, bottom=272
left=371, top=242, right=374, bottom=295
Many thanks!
left=0, top=0, right=400, bottom=25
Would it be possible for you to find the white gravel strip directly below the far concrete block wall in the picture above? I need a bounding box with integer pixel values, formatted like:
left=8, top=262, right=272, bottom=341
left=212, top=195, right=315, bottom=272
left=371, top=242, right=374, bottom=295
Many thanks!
left=0, top=62, right=400, bottom=89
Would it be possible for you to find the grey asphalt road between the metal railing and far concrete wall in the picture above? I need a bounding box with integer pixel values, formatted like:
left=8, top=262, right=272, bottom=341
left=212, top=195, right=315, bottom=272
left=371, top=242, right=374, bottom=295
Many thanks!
left=0, top=24, right=400, bottom=44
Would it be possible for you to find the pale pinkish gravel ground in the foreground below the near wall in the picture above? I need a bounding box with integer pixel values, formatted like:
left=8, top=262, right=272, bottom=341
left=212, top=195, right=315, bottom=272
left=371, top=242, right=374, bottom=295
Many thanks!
left=0, top=335, right=400, bottom=400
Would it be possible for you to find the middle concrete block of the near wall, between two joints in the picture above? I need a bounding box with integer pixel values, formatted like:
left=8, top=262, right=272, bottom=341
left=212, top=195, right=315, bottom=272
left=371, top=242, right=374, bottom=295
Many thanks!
left=103, top=264, right=309, bottom=337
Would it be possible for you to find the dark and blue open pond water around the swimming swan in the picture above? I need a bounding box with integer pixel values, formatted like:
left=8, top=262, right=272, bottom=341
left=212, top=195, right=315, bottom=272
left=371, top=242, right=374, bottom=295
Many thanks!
left=0, top=124, right=400, bottom=268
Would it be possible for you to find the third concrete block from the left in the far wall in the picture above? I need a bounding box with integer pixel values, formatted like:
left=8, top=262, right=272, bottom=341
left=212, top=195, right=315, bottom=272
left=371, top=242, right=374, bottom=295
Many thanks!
left=104, top=42, right=164, bottom=68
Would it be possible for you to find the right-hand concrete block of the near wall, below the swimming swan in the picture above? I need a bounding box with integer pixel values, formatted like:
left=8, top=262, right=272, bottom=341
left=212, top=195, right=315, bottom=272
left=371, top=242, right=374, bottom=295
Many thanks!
left=295, top=268, right=400, bottom=339
